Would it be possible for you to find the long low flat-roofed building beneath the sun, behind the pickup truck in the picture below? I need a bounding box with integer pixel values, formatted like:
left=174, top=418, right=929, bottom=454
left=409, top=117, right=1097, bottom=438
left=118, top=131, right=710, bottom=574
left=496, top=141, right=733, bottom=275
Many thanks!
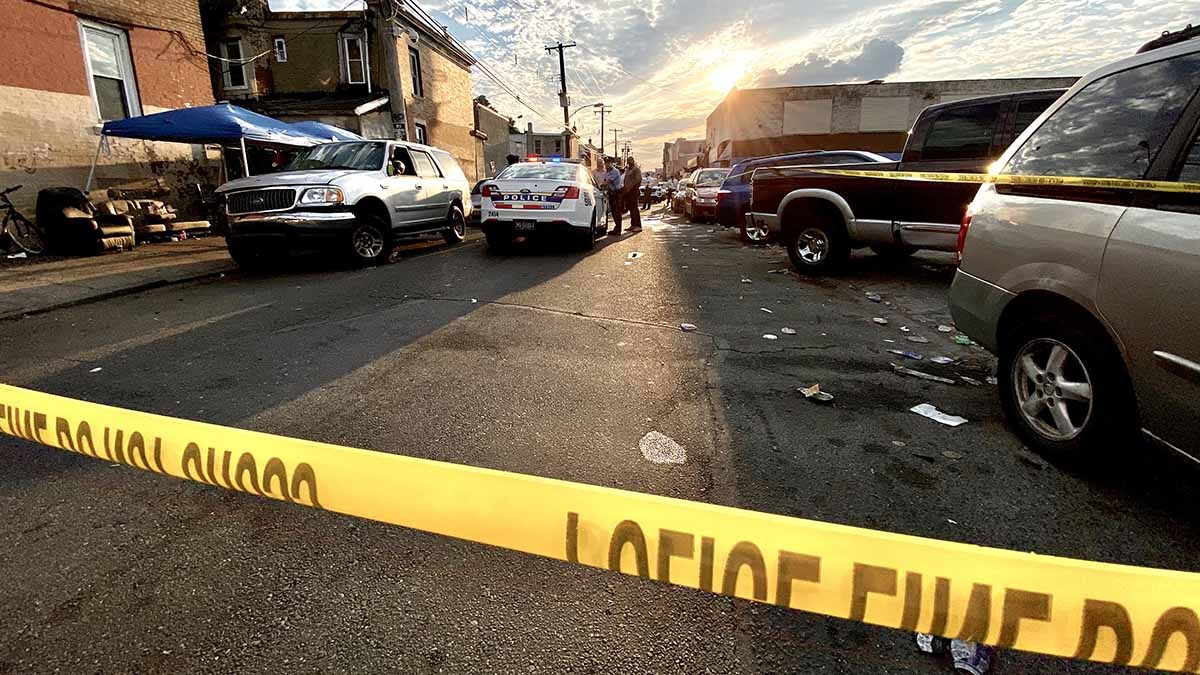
left=704, top=77, right=1076, bottom=167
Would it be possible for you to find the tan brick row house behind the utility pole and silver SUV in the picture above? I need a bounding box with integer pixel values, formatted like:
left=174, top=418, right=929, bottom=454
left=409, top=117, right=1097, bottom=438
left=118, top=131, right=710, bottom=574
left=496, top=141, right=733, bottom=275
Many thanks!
left=206, top=0, right=478, bottom=178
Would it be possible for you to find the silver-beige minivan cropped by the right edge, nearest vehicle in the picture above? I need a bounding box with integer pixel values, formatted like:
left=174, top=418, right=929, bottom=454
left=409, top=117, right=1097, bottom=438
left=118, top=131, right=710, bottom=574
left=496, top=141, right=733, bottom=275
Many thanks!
left=950, top=40, right=1200, bottom=460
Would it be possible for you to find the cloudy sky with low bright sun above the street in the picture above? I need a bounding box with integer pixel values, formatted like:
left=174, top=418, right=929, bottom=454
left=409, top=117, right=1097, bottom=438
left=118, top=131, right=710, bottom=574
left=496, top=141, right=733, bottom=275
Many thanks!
left=270, top=0, right=1200, bottom=168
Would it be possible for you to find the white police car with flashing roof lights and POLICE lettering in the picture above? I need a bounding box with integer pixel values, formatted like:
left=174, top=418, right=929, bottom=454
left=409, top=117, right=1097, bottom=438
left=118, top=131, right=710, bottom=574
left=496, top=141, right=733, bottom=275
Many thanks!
left=480, top=160, right=607, bottom=251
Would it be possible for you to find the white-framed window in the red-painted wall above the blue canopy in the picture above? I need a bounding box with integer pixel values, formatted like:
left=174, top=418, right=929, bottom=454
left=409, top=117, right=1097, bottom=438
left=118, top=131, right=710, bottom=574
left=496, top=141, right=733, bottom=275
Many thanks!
left=79, top=22, right=142, bottom=120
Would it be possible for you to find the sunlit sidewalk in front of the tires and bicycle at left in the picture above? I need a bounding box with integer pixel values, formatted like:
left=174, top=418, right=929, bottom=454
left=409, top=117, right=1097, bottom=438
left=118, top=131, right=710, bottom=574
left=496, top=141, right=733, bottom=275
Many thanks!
left=0, top=237, right=234, bottom=319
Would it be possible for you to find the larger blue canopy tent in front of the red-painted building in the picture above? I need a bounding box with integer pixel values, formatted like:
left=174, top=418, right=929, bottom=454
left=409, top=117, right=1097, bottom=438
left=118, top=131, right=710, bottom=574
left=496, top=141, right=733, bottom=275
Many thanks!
left=84, top=103, right=328, bottom=191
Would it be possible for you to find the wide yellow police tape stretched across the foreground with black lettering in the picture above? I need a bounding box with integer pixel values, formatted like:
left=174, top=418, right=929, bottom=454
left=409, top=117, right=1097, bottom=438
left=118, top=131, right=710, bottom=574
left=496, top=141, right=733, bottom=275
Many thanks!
left=0, top=384, right=1200, bottom=673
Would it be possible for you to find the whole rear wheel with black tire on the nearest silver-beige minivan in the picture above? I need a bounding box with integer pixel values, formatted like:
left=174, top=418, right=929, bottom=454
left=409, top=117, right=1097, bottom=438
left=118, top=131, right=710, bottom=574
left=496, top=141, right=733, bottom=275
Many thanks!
left=997, top=313, right=1138, bottom=462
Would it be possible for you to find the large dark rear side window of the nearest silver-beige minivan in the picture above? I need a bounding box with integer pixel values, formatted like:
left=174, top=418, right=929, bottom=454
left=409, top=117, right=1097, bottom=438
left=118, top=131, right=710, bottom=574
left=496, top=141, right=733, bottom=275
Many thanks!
left=1004, top=54, right=1200, bottom=179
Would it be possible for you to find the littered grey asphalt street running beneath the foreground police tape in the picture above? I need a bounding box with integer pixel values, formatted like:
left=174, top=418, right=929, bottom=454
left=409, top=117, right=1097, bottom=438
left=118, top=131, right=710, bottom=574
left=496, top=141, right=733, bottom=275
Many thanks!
left=0, top=207, right=1200, bottom=674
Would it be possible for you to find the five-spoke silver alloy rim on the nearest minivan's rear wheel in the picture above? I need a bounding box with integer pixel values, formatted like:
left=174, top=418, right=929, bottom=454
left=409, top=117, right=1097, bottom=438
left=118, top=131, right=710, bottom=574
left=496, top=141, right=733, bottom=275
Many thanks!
left=1012, top=338, right=1093, bottom=441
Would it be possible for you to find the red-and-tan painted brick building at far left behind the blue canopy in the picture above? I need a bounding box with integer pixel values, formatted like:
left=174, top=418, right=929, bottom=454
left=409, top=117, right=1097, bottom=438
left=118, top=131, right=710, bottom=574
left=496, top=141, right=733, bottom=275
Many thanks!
left=0, top=0, right=220, bottom=217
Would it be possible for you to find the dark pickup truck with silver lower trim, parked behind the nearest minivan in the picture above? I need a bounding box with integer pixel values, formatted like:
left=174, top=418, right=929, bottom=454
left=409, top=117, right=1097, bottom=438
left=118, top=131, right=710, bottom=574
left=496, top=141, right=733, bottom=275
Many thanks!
left=746, top=89, right=1063, bottom=274
